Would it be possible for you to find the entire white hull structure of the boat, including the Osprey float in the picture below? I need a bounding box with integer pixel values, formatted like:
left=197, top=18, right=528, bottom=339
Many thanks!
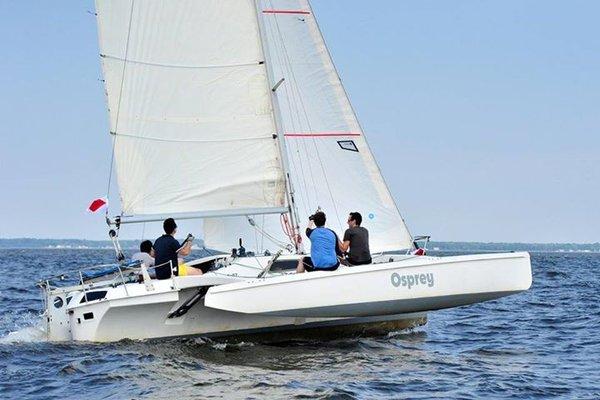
left=41, top=253, right=531, bottom=342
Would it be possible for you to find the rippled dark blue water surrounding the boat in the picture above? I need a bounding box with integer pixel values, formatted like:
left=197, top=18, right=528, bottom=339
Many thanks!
left=0, top=250, right=600, bottom=399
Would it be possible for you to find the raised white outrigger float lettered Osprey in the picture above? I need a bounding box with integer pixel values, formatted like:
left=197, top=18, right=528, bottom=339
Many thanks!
left=206, top=253, right=532, bottom=318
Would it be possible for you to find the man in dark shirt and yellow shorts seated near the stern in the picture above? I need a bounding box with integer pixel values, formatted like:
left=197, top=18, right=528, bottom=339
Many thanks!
left=154, top=218, right=202, bottom=279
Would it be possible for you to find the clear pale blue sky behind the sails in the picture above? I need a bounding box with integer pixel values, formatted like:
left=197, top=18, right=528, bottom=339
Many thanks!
left=0, top=0, right=600, bottom=243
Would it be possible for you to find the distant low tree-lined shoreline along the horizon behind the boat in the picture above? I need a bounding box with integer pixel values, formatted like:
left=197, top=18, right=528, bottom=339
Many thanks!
left=0, top=238, right=600, bottom=253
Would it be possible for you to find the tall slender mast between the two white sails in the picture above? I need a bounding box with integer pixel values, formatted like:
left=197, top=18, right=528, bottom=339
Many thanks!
left=254, top=0, right=300, bottom=252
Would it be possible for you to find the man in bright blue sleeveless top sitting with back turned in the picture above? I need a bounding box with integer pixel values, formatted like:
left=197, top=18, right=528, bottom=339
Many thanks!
left=296, top=211, right=340, bottom=273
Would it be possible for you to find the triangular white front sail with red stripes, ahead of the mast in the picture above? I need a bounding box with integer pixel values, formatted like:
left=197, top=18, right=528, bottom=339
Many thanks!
left=205, top=0, right=413, bottom=252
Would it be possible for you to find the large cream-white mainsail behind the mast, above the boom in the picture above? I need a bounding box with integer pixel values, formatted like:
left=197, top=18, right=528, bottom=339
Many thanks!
left=96, top=0, right=286, bottom=215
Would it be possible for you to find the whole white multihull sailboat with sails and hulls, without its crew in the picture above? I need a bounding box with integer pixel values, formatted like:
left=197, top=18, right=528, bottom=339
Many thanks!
left=40, top=0, right=532, bottom=342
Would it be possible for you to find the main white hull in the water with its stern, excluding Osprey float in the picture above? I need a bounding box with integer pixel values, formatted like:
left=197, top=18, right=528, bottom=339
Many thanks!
left=48, top=278, right=426, bottom=342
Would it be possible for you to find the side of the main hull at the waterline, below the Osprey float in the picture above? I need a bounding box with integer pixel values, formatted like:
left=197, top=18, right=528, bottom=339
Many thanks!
left=63, top=289, right=427, bottom=342
